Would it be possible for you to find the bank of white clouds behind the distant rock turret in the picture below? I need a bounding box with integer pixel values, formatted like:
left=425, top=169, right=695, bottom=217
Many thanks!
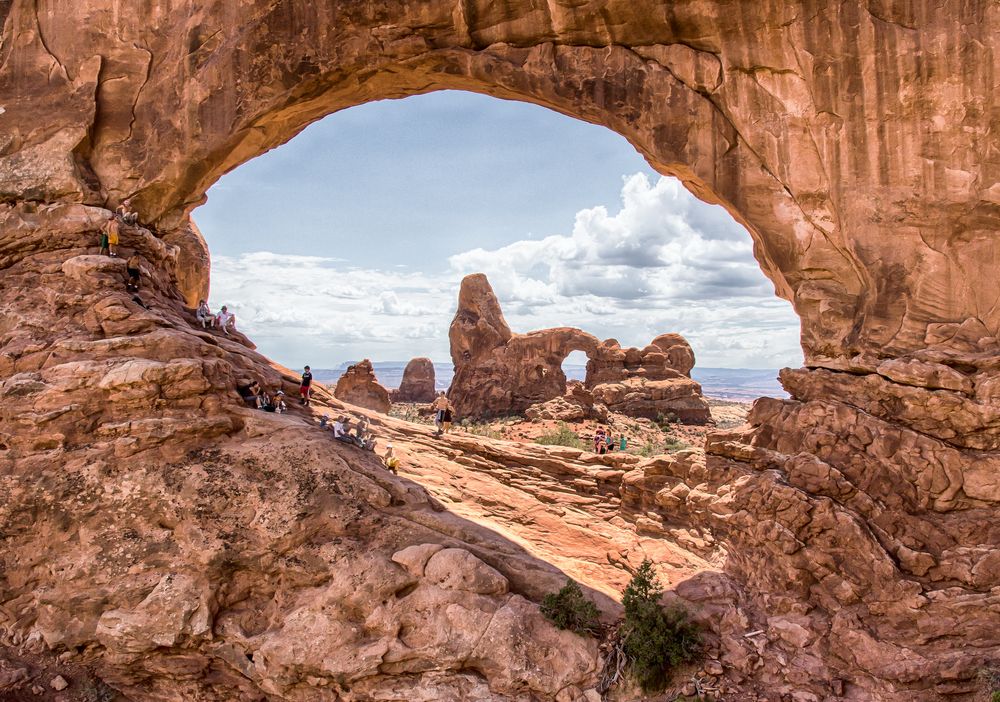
left=212, top=174, right=802, bottom=368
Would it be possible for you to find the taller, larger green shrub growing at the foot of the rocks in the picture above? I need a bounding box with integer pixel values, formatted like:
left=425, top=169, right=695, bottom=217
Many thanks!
left=622, top=559, right=701, bottom=692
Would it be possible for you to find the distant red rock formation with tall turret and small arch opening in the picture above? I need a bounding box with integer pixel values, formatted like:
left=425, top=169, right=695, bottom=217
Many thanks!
left=448, top=273, right=711, bottom=424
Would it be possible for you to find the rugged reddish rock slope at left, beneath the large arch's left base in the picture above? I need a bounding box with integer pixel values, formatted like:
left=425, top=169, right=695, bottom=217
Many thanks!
left=0, top=204, right=598, bottom=702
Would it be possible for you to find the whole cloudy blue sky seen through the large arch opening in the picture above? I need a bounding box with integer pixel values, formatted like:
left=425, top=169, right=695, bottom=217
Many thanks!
left=194, top=92, right=802, bottom=368
